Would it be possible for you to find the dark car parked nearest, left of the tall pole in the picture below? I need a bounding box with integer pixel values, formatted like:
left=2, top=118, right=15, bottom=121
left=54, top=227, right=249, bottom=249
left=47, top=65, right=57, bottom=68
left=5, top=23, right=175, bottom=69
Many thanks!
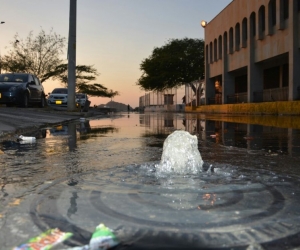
left=0, top=73, right=46, bottom=107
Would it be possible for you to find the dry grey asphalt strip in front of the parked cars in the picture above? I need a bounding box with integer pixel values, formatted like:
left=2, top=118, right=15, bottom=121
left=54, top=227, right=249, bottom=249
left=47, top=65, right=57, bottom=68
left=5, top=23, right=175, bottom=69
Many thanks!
left=0, top=106, right=91, bottom=141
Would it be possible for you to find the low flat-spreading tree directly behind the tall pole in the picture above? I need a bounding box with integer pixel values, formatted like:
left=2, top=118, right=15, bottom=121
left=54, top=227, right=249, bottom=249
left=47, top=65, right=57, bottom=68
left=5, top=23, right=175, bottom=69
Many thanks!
left=44, top=64, right=119, bottom=98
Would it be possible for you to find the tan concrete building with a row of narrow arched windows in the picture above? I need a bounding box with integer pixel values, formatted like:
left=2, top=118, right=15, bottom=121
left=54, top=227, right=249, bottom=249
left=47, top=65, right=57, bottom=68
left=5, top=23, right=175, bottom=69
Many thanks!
left=203, top=0, right=300, bottom=104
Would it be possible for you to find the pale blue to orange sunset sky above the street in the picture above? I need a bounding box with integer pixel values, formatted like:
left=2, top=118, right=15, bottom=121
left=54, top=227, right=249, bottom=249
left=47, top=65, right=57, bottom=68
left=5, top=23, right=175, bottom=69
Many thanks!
left=0, top=0, right=231, bottom=108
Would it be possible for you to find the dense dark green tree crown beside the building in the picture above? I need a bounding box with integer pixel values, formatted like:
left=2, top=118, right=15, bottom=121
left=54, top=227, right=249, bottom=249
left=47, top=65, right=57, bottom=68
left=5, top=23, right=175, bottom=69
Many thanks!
left=137, top=38, right=204, bottom=91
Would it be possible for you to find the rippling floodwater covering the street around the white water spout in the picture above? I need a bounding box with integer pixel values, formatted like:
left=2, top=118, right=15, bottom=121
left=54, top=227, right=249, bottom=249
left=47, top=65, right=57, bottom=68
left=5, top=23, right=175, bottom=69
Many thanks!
left=0, top=113, right=300, bottom=250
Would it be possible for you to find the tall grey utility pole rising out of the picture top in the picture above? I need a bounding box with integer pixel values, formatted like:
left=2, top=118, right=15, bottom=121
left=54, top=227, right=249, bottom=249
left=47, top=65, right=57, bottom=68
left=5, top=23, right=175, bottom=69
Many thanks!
left=68, top=0, right=77, bottom=111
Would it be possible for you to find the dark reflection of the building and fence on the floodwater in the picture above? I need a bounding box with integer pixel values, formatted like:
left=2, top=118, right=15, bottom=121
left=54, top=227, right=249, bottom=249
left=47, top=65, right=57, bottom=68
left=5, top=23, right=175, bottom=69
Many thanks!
left=140, top=113, right=300, bottom=155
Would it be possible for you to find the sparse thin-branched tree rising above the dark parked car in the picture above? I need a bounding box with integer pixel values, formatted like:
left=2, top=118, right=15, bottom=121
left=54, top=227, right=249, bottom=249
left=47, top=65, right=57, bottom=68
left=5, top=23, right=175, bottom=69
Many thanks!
left=1, top=29, right=66, bottom=82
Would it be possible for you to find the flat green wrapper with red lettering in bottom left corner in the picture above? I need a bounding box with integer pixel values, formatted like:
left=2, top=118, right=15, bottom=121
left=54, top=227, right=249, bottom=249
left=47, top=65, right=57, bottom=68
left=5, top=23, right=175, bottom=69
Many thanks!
left=13, top=228, right=73, bottom=250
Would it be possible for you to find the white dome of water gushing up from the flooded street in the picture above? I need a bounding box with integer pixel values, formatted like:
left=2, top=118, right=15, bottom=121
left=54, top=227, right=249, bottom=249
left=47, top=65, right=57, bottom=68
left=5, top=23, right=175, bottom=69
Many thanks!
left=155, top=130, right=203, bottom=176
